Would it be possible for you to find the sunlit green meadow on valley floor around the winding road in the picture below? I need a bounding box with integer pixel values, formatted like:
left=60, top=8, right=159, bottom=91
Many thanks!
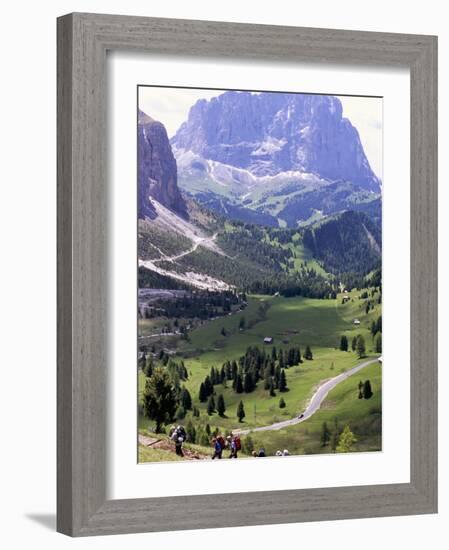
left=139, top=290, right=382, bottom=461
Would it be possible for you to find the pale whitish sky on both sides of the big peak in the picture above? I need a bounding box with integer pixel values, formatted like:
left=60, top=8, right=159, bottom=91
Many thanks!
left=139, top=86, right=382, bottom=179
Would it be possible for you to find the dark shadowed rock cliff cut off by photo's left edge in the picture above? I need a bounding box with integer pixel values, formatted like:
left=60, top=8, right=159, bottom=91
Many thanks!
left=137, top=111, right=187, bottom=218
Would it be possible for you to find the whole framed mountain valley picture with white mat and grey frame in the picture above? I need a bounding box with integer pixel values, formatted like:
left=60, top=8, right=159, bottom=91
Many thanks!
left=58, top=14, right=437, bottom=536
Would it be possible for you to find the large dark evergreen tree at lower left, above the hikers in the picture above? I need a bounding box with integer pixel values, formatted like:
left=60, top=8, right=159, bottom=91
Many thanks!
left=143, top=367, right=178, bottom=433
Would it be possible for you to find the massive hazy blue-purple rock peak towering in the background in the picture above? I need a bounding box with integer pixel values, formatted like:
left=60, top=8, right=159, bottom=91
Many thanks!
left=172, top=92, right=380, bottom=193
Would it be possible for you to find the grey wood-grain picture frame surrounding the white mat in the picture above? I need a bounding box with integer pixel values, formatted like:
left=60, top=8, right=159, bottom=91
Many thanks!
left=57, top=13, right=437, bottom=536
